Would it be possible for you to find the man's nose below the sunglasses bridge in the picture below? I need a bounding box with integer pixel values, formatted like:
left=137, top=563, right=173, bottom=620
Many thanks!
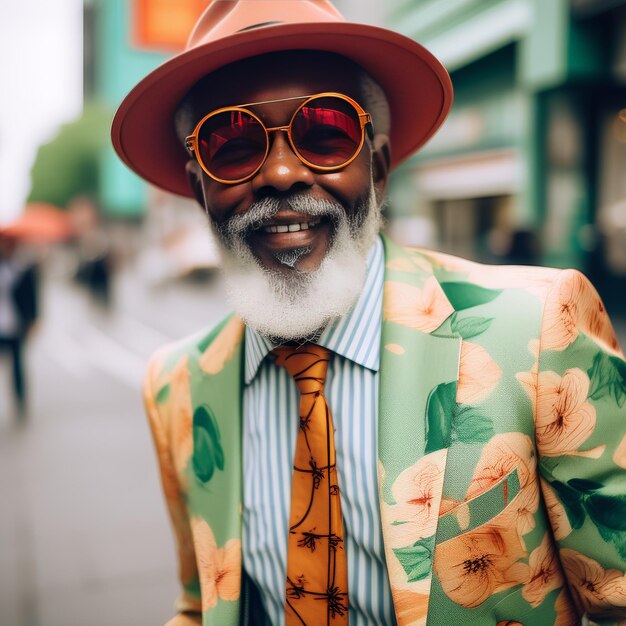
left=252, top=130, right=314, bottom=192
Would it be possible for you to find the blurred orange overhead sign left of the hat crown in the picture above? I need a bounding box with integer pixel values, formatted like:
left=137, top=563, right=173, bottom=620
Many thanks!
left=131, top=0, right=209, bottom=52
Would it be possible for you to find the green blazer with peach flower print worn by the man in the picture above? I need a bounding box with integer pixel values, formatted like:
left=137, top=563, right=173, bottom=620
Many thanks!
left=145, top=235, right=626, bottom=626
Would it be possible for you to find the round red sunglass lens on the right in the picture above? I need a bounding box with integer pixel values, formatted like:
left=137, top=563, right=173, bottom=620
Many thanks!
left=291, top=96, right=363, bottom=167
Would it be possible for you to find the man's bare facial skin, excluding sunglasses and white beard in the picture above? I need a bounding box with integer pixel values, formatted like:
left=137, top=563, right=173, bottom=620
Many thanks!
left=182, top=52, right=386, bottom=273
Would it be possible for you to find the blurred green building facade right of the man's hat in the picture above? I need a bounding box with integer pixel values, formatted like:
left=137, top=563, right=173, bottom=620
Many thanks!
left=388, top=0, right=626, bottom=274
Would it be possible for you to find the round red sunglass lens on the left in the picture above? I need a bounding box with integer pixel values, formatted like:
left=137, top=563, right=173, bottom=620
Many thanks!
left=198, top=111, right=267, bottom=181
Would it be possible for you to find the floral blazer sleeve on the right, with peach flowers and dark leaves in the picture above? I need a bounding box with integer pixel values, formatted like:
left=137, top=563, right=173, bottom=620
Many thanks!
left=535, top=270, right=626, bottom=624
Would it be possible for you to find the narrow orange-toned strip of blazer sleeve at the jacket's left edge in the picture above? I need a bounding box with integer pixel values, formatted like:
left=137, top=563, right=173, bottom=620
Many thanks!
left=144, top=353, right=202, bottom=626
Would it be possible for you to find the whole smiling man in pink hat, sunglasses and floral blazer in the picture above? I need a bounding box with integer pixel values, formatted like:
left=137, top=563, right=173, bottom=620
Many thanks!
left=113, top=0, right=626, bottom=626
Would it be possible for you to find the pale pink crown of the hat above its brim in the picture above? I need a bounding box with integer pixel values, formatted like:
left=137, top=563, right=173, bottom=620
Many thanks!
left=185, top=0, right=345, bottom=50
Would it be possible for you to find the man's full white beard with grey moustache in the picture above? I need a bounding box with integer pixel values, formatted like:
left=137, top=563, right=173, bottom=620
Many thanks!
left=211, top=178, right=381, bottom=340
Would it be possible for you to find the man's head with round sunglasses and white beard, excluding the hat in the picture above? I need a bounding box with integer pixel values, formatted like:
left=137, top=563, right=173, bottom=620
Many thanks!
left=176, top=50, right=389, bottom=339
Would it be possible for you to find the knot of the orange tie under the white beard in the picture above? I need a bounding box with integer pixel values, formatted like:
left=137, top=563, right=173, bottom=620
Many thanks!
left=272, top=343, right=330, bottom=394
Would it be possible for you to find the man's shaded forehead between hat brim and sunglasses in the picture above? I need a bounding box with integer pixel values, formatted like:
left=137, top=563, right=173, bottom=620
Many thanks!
left=189, top=50, right=360, bottom=115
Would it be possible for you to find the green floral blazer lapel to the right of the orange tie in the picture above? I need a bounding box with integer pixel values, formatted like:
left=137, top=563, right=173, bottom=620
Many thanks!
left=378, top=239, right=461, bottom=626
